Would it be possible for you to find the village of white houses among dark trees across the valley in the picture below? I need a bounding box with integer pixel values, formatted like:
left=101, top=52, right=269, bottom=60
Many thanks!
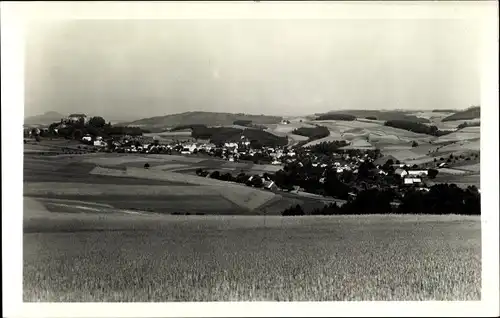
left=25, top=114, right=470, bottom=207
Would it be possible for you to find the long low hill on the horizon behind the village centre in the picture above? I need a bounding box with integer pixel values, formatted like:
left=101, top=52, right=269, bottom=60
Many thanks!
left=122, top=111, right=282, bottom=128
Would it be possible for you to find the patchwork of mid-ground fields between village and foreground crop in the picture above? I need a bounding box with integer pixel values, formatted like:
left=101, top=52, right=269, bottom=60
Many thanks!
left=24, top=153, right=312, bottom=215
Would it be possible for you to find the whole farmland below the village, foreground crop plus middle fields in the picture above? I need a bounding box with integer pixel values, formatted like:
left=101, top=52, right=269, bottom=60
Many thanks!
left=23, top=143, right=481, bottom=302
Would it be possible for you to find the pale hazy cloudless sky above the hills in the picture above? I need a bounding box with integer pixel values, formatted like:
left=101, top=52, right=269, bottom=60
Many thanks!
left=25, top=19, right=480, bottom=120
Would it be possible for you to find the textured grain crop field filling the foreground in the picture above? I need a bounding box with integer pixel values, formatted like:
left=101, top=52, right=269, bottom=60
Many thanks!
left=23, top=215, right=481, bottom=302
